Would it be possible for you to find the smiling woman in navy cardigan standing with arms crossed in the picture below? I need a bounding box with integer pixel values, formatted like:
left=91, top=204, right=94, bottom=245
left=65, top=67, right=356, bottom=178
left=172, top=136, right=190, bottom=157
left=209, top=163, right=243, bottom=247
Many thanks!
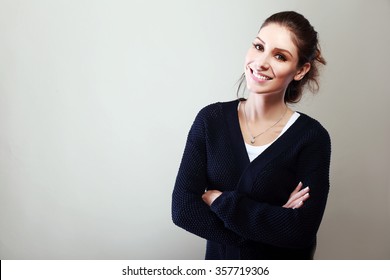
left=172, top=12, right=330, bottom=259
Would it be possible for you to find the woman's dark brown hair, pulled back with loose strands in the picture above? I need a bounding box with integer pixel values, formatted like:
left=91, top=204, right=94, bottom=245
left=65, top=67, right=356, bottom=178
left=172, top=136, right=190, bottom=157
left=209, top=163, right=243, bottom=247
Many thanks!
left=237, top=11, right=326, bottom=103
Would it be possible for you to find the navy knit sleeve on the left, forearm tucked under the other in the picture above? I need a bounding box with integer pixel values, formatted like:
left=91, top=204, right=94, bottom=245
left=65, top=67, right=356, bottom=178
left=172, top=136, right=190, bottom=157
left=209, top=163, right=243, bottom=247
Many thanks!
left=172, top=110, right=243, bottom=245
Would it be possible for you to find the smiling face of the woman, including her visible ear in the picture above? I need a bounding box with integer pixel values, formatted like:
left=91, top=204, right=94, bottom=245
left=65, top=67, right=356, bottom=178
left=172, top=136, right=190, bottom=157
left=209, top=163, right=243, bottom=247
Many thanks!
left=245, top=24, right=306, bottom=95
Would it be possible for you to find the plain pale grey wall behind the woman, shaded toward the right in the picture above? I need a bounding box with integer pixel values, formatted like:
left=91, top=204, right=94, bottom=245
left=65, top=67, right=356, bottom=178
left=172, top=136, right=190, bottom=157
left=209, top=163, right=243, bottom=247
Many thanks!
left=0, top=0, right=390, bottom=259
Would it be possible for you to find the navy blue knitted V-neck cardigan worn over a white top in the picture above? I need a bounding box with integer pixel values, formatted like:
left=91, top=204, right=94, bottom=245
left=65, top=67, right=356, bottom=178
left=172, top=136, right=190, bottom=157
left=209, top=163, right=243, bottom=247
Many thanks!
left=172, top=100, right=331, bottom=259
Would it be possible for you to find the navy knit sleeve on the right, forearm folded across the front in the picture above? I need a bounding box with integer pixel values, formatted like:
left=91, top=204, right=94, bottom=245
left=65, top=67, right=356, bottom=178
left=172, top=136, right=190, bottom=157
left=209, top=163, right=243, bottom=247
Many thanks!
left=211, top=123, right=331, bottom=248
